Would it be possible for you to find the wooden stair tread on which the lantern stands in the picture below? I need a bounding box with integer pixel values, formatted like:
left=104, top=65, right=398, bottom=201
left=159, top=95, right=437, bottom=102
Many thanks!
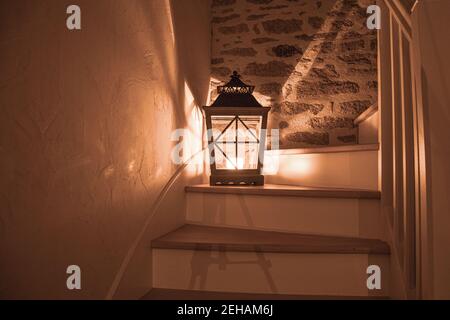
left=185, top=184, right=381, bottom=199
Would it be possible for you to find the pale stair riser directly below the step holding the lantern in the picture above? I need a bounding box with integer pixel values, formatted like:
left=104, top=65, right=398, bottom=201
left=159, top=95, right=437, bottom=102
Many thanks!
left=187, top=193, right=384, bottom=239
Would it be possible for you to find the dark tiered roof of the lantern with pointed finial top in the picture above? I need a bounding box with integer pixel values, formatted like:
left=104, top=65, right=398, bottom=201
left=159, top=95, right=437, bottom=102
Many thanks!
left=211, top=71, right=262, bottom=107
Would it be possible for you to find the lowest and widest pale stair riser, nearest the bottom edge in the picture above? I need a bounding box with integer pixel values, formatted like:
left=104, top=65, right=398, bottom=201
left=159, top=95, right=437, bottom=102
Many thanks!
left=153, top=249, right=389, bottom=296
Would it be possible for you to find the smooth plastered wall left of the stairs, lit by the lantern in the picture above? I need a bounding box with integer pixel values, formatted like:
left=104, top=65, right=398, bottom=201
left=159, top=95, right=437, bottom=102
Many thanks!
left=0, top=0, right=210, bottom=299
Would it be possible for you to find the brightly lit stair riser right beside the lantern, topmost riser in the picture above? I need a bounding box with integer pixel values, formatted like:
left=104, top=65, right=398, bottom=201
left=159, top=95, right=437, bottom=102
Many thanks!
left=265, top=151, right=378, bottom=190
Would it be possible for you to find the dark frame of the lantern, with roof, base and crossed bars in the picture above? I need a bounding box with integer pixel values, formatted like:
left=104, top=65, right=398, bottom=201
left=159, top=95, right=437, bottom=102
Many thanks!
left=203, top=72, right=271, bottom=186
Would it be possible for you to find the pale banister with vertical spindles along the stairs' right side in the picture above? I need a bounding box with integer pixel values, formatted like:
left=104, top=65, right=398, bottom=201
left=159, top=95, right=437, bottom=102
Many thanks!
left=378, top=0, right=423, bottom=298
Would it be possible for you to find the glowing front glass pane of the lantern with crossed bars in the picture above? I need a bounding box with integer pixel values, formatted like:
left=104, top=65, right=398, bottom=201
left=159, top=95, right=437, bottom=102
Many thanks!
left=211, top=116, right=262, bottom=170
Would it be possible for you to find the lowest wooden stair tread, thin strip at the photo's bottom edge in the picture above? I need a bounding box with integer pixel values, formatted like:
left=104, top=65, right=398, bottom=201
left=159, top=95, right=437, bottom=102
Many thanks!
left=141, top=288, right=388, bottom=300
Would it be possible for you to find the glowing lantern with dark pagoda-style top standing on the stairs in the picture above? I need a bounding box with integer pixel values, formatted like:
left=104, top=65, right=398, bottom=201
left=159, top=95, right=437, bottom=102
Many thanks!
left=203, top=71, right=270, bottom=185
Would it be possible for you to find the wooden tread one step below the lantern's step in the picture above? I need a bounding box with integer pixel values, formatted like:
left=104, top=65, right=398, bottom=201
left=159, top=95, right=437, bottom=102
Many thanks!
left=152, top=224, right=390, bottom=254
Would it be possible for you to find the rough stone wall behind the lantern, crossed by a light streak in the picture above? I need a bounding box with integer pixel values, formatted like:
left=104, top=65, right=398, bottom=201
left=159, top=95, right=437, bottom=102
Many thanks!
left=211, top=0, right=377, bottom=148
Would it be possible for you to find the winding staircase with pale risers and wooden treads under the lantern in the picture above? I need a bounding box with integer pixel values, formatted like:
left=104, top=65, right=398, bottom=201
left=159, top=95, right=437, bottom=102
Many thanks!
left=144, top=109, right=390, bottom=300
